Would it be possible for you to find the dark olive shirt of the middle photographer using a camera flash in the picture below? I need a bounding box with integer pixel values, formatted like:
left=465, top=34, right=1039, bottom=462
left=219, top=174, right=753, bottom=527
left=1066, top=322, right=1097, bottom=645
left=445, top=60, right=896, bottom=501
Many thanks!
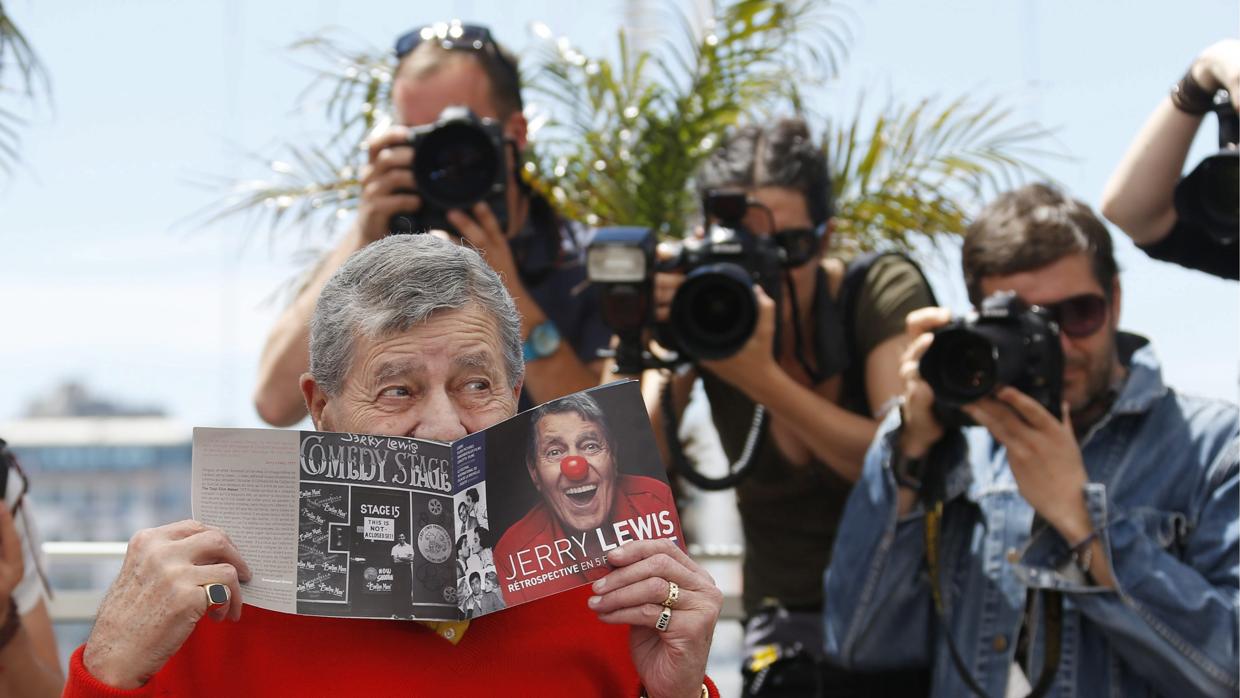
left=702, top=255, right=934, bottom=615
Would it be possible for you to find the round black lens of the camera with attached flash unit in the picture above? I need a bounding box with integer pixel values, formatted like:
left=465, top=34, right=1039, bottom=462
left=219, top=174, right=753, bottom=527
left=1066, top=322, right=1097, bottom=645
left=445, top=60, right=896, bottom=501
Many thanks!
left=670, top=263, right=758, bottom=360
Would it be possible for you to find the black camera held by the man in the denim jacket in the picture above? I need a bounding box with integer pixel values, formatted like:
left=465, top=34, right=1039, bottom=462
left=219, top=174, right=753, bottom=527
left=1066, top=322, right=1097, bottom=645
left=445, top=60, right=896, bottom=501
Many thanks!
left=920, top=291, right=1064, bottom=426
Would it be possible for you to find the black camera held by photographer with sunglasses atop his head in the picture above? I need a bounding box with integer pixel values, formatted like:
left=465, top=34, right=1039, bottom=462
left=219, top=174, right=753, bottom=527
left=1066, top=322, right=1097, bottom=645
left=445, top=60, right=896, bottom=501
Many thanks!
left=388, top=107, right=508, bottom=234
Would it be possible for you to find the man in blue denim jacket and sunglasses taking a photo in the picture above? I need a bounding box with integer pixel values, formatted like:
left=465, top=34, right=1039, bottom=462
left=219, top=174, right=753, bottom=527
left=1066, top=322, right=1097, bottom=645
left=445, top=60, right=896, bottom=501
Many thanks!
left=825, top=185, right=1240, bottom=697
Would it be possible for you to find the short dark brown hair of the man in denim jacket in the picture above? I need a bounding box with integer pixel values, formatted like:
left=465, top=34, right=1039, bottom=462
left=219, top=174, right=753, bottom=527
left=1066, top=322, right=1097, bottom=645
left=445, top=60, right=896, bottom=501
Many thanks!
left=961, top=183, right=1120, bottom=306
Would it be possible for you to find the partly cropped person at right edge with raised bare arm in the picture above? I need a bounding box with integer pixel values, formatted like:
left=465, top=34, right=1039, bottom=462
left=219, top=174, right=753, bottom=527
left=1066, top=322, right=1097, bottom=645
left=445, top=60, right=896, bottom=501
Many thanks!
left=1101, top=38, right=1240, bottom=279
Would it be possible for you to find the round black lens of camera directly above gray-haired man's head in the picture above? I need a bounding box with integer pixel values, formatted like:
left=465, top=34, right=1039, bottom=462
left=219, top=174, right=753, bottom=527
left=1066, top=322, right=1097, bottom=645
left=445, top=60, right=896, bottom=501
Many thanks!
left=413, top=121, right=500, bottom=208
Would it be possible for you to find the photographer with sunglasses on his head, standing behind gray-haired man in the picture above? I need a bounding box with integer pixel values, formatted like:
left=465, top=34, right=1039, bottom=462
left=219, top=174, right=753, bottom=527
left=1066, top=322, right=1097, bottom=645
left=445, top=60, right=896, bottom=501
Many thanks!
left=254, top=22, right=610, bottom=426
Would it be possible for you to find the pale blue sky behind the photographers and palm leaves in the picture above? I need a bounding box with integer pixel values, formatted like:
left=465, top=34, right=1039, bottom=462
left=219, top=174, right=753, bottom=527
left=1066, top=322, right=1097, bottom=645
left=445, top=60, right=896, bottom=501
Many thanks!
left=0, top=0, right=1240, bottom=425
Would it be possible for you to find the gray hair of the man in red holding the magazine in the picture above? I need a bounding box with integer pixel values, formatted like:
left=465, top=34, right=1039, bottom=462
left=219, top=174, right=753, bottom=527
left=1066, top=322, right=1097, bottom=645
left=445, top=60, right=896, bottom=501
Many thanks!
left=310, top=234, right=526, bottom=395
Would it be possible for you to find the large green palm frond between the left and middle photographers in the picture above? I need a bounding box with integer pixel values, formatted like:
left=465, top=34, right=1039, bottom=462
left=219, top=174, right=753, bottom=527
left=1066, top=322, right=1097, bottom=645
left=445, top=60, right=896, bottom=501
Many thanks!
left=527, top=0, right=851, bottom=236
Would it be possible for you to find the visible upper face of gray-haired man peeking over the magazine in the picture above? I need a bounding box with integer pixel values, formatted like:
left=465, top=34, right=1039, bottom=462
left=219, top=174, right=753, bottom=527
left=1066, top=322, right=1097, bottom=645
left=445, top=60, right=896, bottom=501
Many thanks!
left=301, top=304, right=521, bottom=441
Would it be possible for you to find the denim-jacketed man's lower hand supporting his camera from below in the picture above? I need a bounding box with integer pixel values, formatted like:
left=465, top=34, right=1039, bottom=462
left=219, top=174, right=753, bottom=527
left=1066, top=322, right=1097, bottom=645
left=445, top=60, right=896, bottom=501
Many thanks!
left=963, top=387, right=1091, bottom=542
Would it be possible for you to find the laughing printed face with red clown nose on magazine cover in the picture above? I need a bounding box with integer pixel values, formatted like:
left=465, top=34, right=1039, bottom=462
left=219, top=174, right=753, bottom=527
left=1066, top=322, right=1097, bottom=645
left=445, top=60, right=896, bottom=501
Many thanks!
left=529, top=412, right=616, bottom=531
